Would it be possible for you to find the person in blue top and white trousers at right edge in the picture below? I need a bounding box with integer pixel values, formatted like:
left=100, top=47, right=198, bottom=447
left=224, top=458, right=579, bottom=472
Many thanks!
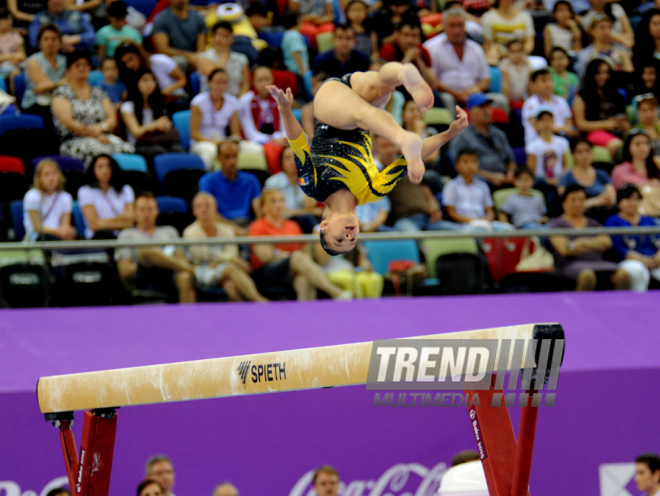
left=605, top=183, right=660, bottom=291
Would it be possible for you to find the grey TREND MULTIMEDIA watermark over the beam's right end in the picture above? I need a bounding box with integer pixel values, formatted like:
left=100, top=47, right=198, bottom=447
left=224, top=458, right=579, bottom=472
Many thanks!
left=367, top=339, right=564, bottom=408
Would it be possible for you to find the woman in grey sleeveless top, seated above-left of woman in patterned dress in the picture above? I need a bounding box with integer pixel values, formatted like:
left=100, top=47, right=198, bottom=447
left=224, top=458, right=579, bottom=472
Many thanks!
left=21, top=24, right=66, bottom=135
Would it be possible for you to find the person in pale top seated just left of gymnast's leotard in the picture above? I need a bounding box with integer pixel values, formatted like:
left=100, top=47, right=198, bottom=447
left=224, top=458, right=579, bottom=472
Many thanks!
left=264, top=146, right=321, bottom=234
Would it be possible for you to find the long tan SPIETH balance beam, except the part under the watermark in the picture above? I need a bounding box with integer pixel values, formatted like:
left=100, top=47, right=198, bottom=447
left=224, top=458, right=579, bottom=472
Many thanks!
left=37, top=324, right=563, bottom=414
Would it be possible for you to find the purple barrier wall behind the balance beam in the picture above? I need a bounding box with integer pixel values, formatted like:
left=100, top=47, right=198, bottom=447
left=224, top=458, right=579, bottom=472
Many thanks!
left=0, top=293, right=660, bottom=496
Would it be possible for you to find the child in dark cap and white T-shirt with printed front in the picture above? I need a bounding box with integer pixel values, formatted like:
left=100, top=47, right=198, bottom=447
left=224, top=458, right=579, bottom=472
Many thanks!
left=525, top=107, right=569, bottom=186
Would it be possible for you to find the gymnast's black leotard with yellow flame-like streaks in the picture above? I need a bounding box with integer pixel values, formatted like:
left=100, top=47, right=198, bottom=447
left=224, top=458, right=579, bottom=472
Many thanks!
left=289, top=74, right=407, bottom=205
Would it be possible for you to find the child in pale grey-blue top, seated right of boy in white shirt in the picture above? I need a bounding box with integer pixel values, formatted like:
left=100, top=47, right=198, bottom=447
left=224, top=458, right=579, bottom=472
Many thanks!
left=500, top=167, right=548, bottom=229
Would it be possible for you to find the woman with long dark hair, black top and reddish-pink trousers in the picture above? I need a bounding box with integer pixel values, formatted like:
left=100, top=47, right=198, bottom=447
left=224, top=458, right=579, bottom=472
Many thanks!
left=573, top=59, right=630, bottom=156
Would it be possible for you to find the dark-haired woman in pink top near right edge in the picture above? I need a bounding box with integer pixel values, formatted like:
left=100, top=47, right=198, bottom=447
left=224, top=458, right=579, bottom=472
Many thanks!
left=612, top=129, right=660, bottom=190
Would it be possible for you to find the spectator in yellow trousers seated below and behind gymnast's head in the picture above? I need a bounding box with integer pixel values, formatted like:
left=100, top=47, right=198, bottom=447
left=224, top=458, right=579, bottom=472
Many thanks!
left=314, top=229, right=385, bottom=299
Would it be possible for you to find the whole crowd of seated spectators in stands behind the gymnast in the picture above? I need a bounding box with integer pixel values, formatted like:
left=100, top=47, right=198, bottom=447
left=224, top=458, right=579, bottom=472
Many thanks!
left=0, top=0, right=660, bottom=302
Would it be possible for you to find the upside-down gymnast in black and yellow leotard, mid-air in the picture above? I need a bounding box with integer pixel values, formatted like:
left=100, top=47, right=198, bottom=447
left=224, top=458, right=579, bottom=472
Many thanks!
left=268, top=62, right=468, bottom=255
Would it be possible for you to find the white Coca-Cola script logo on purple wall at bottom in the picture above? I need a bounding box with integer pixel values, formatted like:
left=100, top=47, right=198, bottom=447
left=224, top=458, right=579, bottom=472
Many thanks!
left=289, top=463, right=447, bottom=496
